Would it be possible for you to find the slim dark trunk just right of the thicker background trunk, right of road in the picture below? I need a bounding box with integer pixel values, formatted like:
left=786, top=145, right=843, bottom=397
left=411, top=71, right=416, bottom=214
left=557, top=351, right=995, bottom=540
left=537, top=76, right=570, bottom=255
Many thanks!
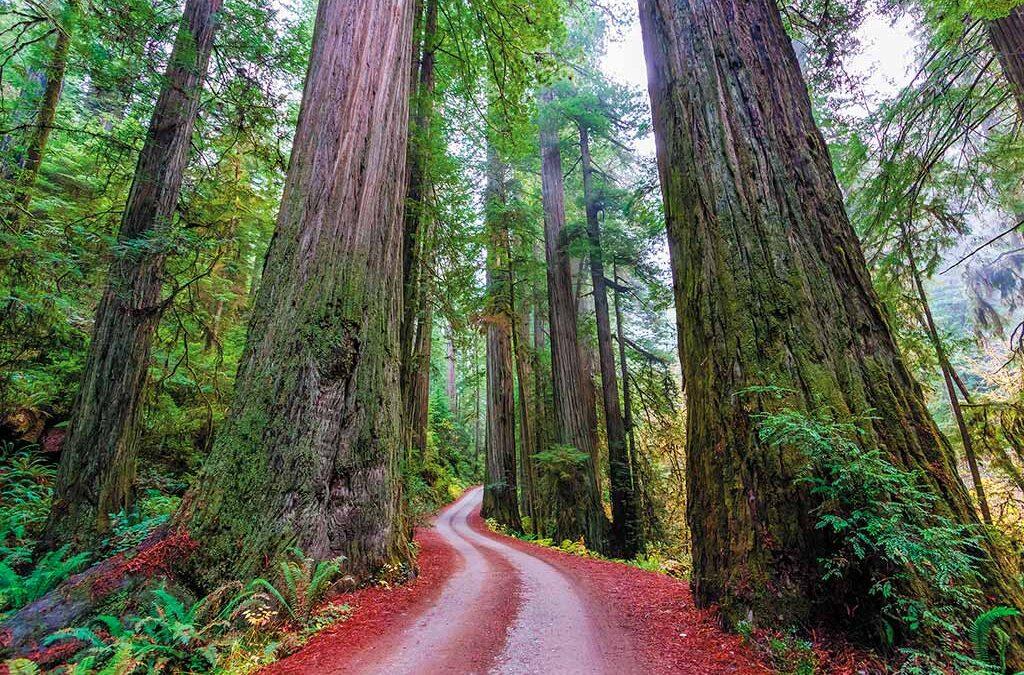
left=580, top=125, right=640, bottom=558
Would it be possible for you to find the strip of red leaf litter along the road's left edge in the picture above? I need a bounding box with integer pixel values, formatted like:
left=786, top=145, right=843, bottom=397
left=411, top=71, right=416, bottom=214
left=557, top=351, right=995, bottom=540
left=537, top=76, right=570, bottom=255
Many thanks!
left=268, top=529, right=463, bottom=675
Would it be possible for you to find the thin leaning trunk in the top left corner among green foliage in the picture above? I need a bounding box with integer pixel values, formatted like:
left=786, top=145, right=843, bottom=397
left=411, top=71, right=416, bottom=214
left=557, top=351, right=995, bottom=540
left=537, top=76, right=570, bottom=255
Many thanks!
left=8, top=0, right=79, bottom=231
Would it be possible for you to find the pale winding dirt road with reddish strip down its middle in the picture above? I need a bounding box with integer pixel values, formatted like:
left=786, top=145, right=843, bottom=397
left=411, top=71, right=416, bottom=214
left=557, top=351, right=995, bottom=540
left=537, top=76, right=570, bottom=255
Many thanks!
left=307, top=488, right=644, bottom=675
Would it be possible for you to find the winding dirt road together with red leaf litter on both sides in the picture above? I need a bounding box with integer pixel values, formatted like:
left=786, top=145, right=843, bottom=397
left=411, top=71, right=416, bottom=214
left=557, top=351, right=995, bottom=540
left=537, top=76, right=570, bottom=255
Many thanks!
left=263, top=488, right=772, bottom=675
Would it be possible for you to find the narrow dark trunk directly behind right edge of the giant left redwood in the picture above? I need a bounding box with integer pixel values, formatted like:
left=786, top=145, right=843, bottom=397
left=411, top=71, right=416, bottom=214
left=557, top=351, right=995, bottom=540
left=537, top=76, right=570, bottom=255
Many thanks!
left=400, top=0, right=437, bottom=457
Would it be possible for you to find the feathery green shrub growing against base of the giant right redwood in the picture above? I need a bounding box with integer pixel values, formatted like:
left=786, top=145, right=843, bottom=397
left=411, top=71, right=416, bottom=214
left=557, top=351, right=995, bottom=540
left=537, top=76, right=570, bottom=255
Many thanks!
left=755, top=387, right=1024, bottom=674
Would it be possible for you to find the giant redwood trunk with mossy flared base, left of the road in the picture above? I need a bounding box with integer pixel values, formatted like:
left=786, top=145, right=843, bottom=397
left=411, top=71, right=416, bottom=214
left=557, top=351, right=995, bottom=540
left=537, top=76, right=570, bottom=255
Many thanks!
left=175, top=0, right=413, bottom=587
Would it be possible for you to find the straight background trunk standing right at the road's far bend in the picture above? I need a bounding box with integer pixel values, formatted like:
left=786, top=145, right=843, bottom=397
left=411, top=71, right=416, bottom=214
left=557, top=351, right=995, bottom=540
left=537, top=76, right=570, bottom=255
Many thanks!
left=480, top=147, right=522, bottom=532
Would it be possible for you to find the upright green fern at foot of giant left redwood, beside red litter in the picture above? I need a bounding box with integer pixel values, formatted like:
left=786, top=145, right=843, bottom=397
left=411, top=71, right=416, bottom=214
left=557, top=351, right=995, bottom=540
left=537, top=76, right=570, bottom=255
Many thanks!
left=248, top=548, right=344, bottom=626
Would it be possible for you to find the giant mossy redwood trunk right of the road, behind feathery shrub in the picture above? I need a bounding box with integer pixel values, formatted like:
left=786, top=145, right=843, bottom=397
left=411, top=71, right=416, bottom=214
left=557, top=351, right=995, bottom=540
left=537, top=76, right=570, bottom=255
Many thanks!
left=639, top=0, right=1021, bottom=651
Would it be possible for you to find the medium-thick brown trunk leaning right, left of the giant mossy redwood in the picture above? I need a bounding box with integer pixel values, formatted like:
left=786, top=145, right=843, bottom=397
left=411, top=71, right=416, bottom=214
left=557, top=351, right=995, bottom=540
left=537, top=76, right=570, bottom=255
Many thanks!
left=42, top=0, right=221, bottom=548
